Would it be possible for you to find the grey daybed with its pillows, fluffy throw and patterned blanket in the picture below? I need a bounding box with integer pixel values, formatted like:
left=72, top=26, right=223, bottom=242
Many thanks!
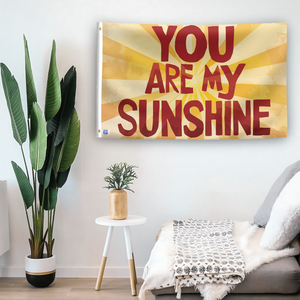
left=139, top=161, right=300, bottom=300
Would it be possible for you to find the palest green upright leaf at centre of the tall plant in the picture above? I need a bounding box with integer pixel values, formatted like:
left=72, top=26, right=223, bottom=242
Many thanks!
left=29, top=102, right=47, bottom=171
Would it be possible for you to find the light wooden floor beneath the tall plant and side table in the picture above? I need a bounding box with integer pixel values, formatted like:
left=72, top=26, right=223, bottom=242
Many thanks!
left=0, top=277, right=154, bottom=300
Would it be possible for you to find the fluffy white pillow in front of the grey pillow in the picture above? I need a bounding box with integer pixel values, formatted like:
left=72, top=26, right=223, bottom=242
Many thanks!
left=260, top=172, right=300, bottom=250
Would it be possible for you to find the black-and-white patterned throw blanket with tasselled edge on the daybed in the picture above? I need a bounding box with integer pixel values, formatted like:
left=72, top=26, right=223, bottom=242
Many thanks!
left=173, top=219, right=245, bottom=288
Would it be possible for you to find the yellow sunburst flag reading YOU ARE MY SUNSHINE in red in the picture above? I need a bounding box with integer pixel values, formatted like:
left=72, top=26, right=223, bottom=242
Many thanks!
left=97, top=23, right=287, bottom=140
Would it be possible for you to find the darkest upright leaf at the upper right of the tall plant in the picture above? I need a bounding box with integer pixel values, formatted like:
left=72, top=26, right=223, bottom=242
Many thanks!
left=54, top=67, right=76, bottom=146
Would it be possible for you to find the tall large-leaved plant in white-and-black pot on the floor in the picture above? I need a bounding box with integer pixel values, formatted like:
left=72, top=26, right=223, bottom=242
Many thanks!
left=0, top=36, right=80, bottom=287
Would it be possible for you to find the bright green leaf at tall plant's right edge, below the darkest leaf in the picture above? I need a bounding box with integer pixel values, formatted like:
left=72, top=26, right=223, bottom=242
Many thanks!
left=53, top=108, right=80, bottom=174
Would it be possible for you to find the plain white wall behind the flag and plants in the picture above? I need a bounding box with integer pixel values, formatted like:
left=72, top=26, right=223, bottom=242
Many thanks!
left=0, top=0, right=300, bottom=277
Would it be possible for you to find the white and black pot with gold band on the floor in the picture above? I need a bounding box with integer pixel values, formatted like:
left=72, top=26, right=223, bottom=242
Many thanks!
left=25, top=254, right=56, bottom=287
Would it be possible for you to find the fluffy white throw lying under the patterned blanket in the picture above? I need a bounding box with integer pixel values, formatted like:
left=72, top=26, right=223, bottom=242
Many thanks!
left=139, top=221, right=300, bottom=300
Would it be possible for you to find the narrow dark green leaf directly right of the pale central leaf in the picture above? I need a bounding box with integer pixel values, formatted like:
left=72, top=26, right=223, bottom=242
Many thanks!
left=38, top=133, right=55, bottom=189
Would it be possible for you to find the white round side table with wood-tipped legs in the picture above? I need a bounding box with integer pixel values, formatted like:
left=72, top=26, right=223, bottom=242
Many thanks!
left=95, top=215, right=147, bottom=296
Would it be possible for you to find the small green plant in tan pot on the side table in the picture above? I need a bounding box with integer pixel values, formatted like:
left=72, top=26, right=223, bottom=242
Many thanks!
left=104, top=163, right=138, bottom=220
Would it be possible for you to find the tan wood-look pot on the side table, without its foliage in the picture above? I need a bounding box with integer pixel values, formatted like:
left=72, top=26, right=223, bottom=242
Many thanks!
left=109, top=190, right=128, bottom=220
